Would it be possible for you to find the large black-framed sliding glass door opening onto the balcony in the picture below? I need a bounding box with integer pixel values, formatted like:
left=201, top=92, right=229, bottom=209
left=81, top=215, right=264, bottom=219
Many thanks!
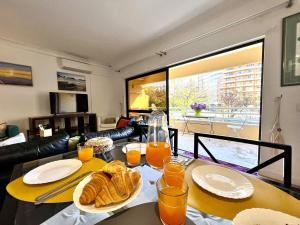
left=126, top=40, right=263, bottom=168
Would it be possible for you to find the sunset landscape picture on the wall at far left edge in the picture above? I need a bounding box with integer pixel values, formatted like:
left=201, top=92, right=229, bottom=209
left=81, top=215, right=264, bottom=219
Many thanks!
left=0, top=62, right=33, bottom=86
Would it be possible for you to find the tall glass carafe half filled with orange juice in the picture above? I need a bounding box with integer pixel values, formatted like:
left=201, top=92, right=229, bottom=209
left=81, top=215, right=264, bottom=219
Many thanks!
left=146, top=110, right=171, bottom=169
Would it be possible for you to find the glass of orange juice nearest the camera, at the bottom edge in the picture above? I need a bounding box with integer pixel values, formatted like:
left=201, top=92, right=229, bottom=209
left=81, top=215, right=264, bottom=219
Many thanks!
left=156, top=177, right=188, bottom=225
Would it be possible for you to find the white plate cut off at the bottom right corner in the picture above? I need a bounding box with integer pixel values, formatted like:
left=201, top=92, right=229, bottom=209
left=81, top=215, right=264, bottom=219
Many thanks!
left=232, top=208, right=300, bottom=225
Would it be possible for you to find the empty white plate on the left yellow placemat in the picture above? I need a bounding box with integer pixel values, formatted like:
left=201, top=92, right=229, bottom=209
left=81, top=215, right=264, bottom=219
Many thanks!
left=23, top=159, right=82, bottom=184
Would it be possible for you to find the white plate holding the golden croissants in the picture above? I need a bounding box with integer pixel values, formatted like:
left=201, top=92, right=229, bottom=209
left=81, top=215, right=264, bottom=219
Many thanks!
left=73, top=171, right=143, bottom=213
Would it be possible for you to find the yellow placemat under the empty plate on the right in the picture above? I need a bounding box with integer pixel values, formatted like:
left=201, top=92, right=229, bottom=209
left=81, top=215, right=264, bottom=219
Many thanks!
left=186, top=160, right=300, bottom=220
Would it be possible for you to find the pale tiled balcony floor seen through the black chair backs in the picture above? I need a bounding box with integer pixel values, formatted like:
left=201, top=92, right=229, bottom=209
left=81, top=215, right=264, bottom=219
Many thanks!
left=178, top=133, right=258, bottom=168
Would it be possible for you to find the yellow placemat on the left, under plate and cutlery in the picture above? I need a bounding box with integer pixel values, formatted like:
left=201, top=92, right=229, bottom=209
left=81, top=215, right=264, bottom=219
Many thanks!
left=6, top=158, right=106, bottom=203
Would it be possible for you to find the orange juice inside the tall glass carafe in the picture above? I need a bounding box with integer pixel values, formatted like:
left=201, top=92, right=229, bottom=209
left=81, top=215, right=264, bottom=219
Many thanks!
left=146, top=142, right=171, bottom=168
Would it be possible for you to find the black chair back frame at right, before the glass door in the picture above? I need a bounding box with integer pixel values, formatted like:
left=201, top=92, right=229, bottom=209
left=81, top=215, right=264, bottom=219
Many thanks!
left=194, top=133, right=292, bottom=188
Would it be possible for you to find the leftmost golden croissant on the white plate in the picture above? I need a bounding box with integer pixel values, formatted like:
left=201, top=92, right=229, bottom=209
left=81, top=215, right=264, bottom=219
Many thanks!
left=79, top=172, right=110, bottom=205
